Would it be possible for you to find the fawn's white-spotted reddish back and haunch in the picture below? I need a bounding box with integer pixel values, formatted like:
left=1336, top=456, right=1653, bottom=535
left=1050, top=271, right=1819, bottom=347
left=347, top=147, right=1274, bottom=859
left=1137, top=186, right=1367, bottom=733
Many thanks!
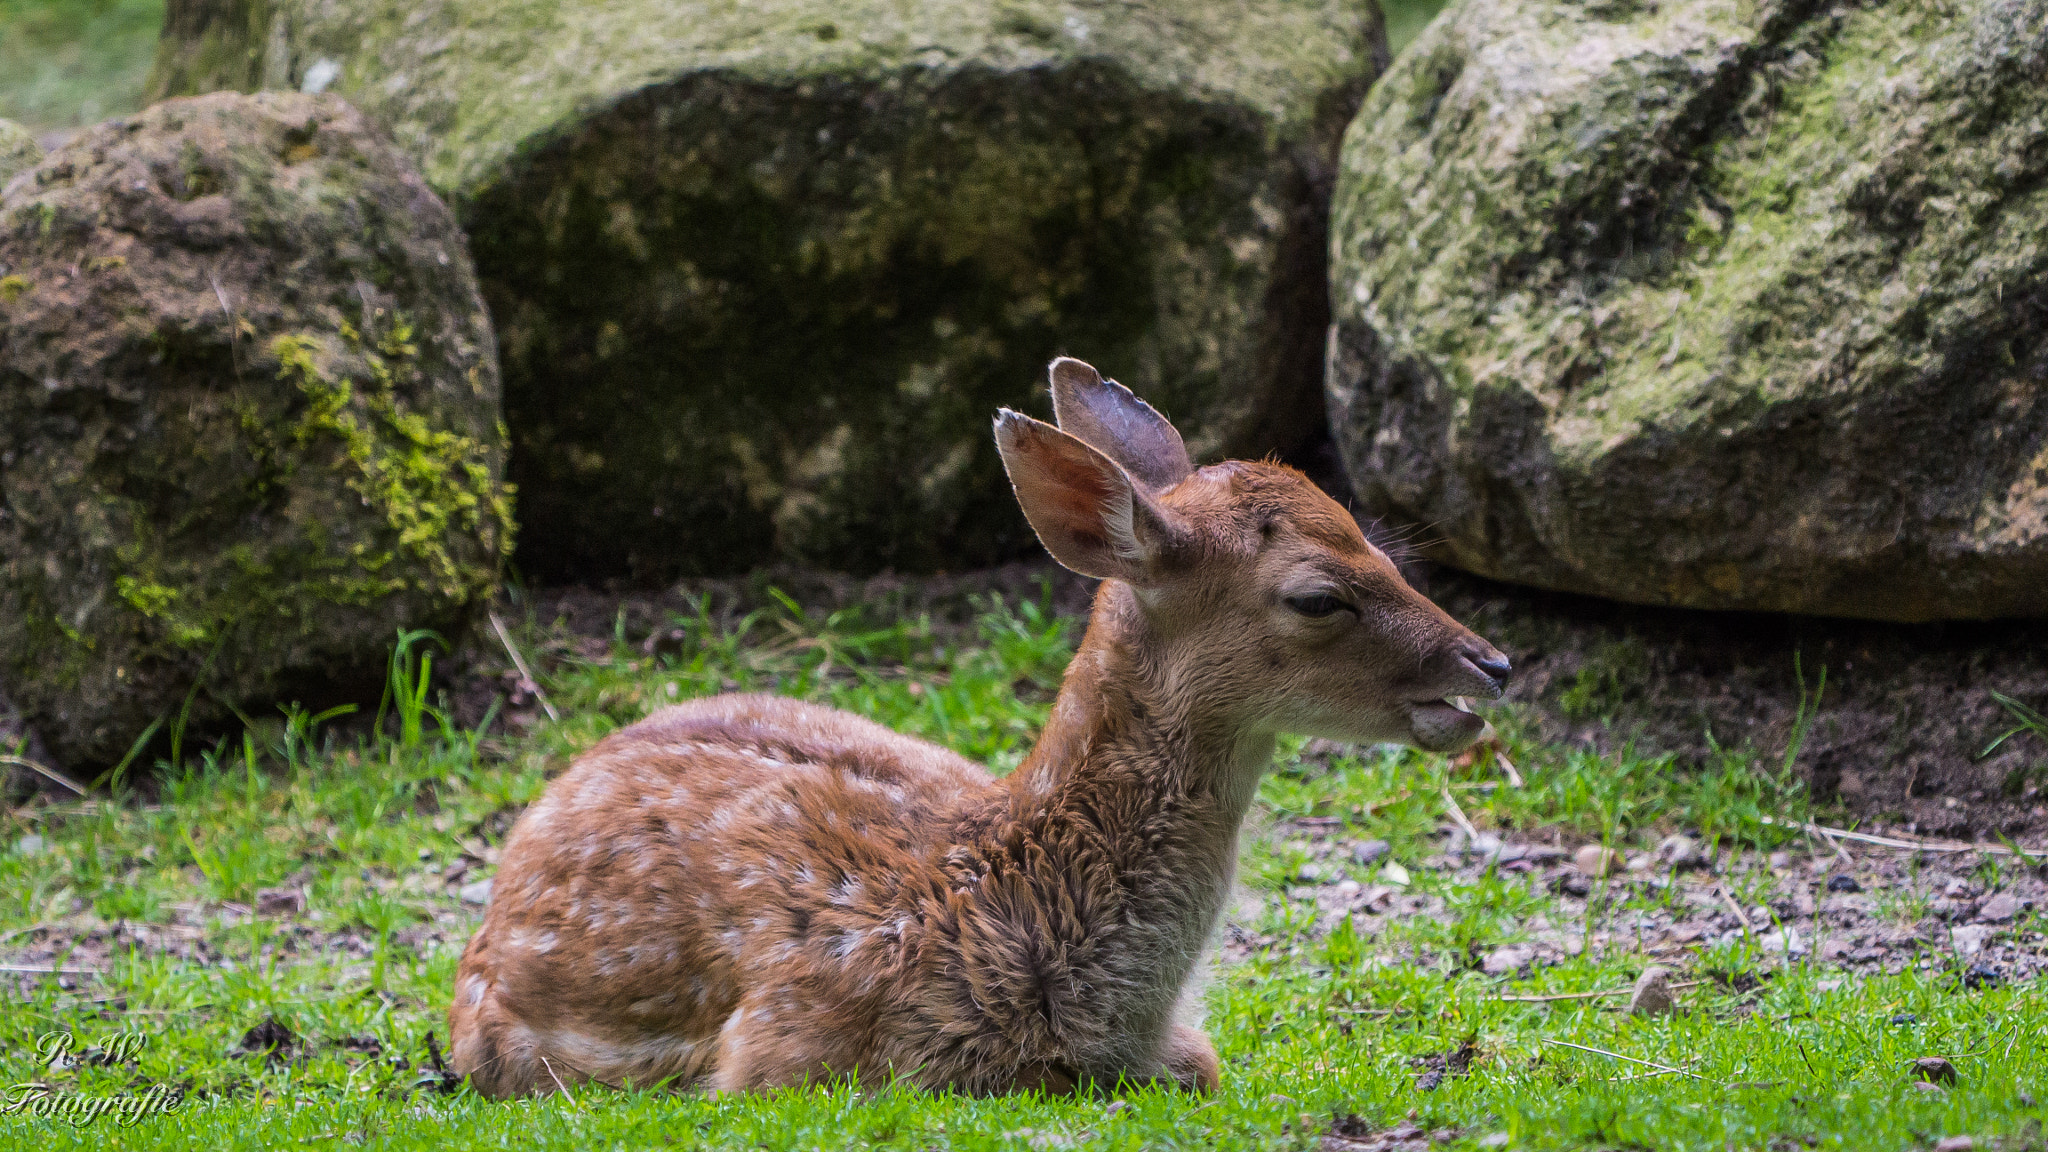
left=455, top=695, right=993, bottom=1082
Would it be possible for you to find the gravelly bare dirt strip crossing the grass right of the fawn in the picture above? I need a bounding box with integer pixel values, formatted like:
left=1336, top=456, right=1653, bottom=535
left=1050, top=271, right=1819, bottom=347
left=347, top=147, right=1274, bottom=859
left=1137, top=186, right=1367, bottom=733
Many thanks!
left=1225, top=807, right=2048, bottom=984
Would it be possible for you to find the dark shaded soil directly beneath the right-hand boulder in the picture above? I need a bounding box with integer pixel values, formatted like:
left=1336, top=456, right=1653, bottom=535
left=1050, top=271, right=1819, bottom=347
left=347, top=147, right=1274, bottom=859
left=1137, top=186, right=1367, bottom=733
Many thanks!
left=1409, top=566, right=2048, bottom=832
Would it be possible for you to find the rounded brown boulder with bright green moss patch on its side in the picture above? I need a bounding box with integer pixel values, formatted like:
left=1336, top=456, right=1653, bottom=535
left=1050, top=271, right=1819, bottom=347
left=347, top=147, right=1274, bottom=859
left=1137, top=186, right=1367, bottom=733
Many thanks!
left=0, top=92, right=510, bottom=765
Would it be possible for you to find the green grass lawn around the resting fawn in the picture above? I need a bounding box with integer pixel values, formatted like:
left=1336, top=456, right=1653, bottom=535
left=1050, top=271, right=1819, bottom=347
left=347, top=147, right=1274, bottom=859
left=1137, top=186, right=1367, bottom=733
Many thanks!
left=0, top=586, right=2048, bottom=1152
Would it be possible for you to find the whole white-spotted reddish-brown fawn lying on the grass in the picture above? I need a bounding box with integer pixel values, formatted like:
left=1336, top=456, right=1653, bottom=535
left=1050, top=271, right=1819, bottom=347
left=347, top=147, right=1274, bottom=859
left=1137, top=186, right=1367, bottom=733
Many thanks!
left=449, top=359, right=1507, bottom=1097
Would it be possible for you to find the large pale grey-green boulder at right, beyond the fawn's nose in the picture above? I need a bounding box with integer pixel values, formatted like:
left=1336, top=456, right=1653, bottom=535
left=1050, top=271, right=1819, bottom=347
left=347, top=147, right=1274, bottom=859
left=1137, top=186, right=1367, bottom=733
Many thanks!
left=1329, top=0, right=2048, bottom=621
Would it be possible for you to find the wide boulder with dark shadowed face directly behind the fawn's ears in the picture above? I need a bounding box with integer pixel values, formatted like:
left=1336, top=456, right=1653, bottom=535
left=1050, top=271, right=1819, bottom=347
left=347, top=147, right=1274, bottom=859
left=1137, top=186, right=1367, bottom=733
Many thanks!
left=158, top=0, right=1384, bottom=580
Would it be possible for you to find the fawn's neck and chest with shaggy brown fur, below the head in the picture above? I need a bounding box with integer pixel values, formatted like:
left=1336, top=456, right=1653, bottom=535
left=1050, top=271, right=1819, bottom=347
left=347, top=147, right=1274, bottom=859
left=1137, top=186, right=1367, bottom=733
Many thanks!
left=991, top=582, right=1274, bottom=1066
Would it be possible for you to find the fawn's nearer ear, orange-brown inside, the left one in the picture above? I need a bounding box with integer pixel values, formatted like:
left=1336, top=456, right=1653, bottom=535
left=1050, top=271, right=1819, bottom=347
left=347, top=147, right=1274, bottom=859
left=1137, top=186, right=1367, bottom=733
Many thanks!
left=995, top=408, right=1180, bottom=586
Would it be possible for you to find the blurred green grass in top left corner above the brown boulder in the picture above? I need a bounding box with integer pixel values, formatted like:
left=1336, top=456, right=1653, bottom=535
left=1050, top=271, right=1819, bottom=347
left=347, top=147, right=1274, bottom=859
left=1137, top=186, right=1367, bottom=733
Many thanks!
left=0, top=0, right=164, bottom=131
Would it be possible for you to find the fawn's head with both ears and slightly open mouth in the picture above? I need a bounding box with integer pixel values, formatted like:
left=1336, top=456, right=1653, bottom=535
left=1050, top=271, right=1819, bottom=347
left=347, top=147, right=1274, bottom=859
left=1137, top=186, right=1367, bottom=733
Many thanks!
left=995, top=357, right=1509, bottom=752
